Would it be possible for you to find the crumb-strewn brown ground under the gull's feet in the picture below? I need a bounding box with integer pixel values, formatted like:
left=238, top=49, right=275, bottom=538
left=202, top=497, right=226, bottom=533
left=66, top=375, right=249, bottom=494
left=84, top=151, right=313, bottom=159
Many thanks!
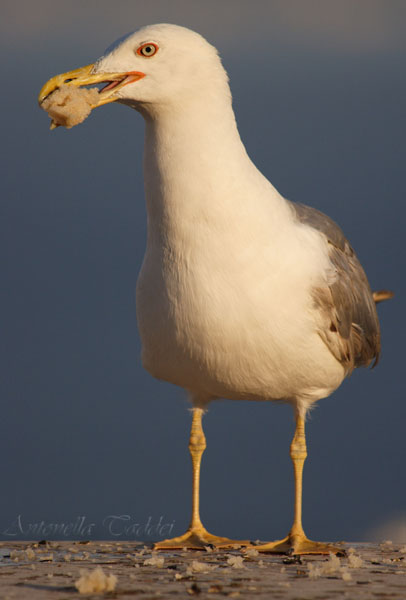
left=0, top=541, right=406, bottom=600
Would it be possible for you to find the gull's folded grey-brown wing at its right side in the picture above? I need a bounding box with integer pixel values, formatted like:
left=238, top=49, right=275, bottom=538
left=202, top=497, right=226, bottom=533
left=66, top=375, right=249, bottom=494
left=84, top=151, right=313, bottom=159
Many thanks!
left=289, top=202, right=381, bottom=374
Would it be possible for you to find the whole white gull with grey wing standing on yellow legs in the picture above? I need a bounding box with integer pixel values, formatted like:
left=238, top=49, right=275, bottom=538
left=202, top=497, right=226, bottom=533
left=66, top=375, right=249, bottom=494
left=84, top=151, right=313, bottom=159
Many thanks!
left=39, top=24, right=391, bottom=554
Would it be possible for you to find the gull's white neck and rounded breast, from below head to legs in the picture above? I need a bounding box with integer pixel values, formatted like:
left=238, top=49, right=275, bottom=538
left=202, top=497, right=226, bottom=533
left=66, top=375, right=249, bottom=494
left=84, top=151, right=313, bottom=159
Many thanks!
left=137, top=86, right=344, bottom=410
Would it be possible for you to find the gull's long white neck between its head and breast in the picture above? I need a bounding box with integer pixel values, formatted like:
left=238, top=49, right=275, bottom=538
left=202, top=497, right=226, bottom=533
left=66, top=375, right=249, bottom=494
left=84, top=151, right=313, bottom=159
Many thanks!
left=139, top=84, right=285, bottom=245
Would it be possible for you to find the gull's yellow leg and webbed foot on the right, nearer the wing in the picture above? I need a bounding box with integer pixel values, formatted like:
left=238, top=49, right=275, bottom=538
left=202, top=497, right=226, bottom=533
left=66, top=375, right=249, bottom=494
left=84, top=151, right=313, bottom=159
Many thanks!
left=256, top=416, right=344, bottom=554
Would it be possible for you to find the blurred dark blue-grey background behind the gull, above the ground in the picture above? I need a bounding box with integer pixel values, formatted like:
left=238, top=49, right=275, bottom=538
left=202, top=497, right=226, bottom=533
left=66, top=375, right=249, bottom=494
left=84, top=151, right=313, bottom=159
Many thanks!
left=0, top=0, right=406, bottom=541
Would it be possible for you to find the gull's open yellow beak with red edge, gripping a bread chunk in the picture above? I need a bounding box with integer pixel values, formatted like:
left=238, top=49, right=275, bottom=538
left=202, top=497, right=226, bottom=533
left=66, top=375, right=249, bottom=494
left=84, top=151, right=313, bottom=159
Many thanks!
left=38, top=64, right=145, bottom=129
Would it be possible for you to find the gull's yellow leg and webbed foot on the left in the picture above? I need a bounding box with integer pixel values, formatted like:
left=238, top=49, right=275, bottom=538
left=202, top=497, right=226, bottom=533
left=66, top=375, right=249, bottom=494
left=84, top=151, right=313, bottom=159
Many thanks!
left=154, top=408, right=250, bottom=550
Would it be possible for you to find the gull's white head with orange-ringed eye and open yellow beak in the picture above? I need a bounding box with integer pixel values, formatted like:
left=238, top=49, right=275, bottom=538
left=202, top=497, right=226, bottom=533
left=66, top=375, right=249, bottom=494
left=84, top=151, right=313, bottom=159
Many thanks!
left=38, top=24, right=230, bottom=118
